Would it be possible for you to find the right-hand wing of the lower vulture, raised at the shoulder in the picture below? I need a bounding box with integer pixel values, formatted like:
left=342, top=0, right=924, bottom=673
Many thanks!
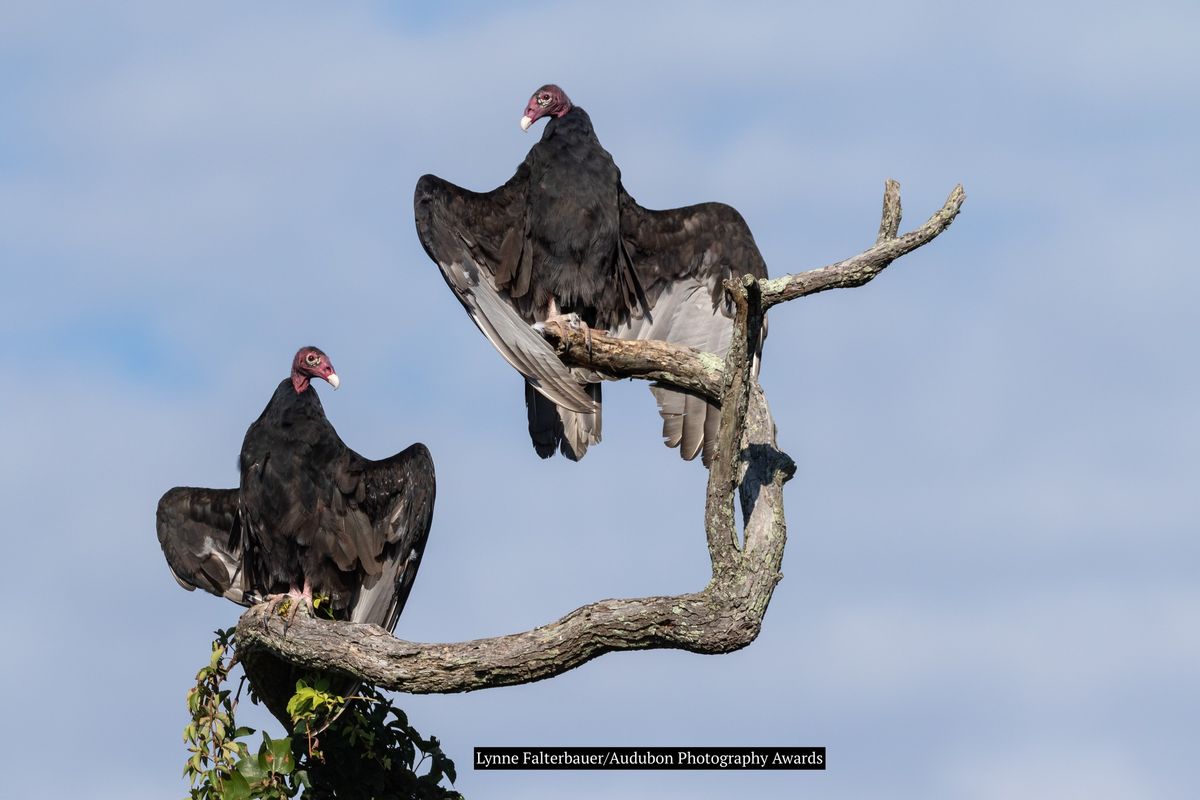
left=340, top=444, right=436, bottom=631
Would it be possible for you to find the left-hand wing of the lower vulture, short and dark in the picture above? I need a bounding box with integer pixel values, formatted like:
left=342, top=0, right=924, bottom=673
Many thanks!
left=157, top=486, right=257, bottom=606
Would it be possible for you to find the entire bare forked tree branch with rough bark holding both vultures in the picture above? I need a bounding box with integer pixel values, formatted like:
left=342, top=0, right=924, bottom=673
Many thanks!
left=238, top=181, right=965, bottom=694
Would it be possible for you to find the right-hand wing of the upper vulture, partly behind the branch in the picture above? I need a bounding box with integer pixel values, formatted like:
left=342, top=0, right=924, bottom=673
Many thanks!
left=613, top=187, right=767, bottom=465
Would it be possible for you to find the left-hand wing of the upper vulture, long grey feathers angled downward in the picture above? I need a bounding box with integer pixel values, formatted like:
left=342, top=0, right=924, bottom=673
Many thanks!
left=414, top=172, right=593, bottom=413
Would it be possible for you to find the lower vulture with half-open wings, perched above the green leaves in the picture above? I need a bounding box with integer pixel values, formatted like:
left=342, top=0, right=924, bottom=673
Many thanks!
left=158, top=347, right=434, bottom=630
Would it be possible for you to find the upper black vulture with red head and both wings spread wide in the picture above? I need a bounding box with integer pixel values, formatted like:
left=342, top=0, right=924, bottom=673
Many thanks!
left=414, top=85, right=767, bottom=464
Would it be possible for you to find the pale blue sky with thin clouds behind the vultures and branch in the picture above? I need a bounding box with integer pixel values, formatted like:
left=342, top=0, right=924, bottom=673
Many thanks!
left=0, top=0, right=1200, bottom=800
